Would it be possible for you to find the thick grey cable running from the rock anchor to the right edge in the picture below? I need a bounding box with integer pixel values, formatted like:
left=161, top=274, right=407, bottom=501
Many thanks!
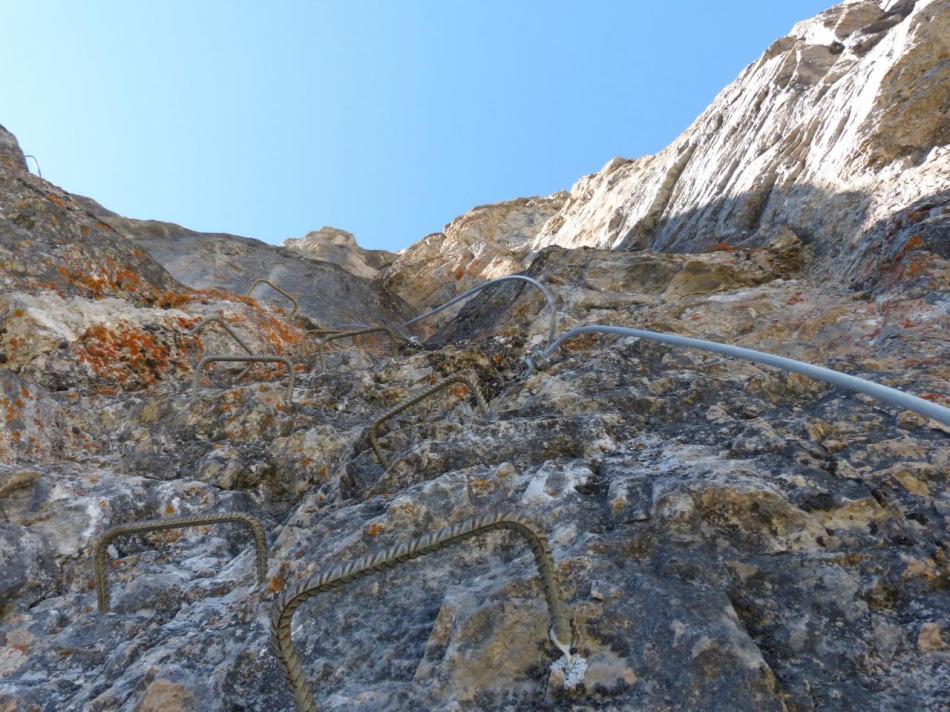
left=527, top=324, right=950, bottom=425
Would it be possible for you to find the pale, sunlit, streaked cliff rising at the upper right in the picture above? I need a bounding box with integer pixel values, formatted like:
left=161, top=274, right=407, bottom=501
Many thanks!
left=533, top=0, right=950, bottom=294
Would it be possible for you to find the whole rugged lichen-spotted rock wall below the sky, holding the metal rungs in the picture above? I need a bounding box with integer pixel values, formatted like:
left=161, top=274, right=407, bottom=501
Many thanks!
left=0, top=2, right=950, bottom=712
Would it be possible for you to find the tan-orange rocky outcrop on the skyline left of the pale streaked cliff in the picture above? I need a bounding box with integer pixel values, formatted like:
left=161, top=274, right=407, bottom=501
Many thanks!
left=377, top=193, right=567, bottom=323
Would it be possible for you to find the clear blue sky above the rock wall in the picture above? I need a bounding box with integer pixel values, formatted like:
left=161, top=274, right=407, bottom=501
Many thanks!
left=0, top=0, right=832, bottom=250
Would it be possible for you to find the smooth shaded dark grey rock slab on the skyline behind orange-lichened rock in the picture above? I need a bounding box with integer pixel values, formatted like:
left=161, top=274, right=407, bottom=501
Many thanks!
left=76, top=197, right=411, bottom=326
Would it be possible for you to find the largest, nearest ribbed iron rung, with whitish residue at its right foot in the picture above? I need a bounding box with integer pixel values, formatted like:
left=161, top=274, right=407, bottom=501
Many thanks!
left=271, top=513, right=578, bottom=712
